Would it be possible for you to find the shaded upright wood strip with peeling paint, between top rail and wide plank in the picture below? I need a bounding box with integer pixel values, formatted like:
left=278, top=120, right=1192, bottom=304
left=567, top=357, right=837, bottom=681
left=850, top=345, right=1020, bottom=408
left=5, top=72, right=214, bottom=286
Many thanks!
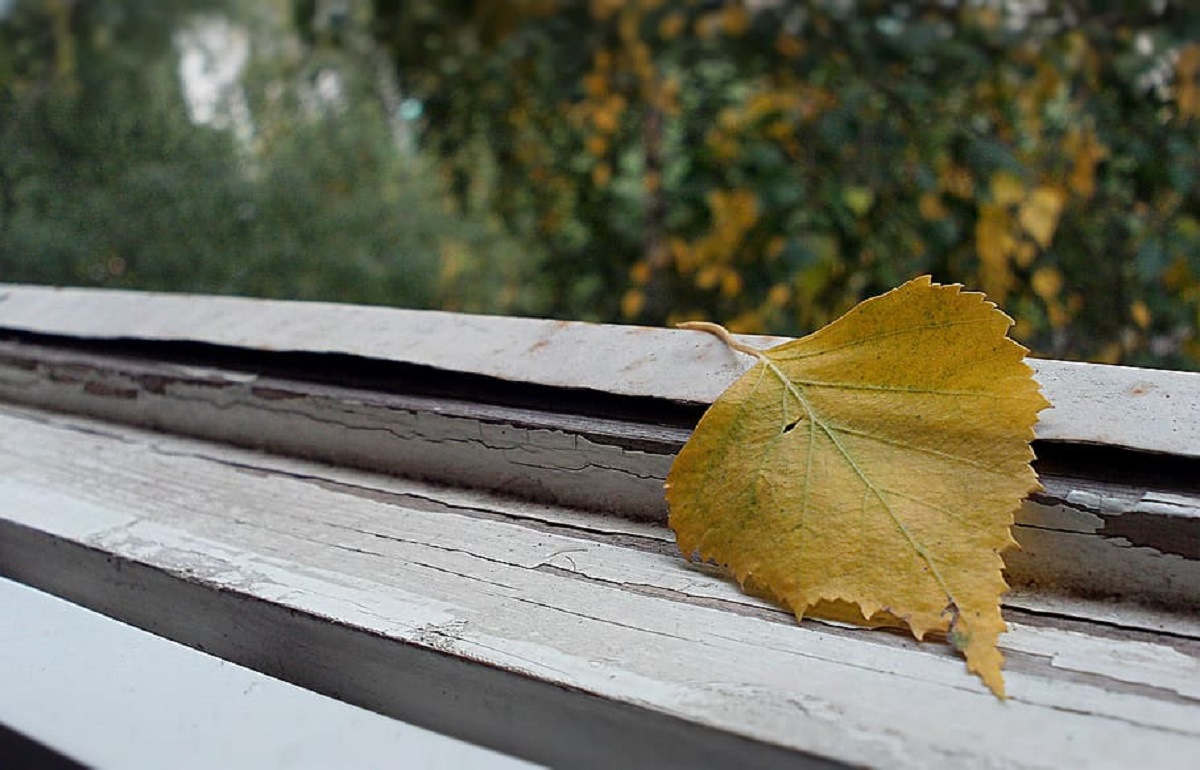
left=0, top=342, right=1200, bottom=622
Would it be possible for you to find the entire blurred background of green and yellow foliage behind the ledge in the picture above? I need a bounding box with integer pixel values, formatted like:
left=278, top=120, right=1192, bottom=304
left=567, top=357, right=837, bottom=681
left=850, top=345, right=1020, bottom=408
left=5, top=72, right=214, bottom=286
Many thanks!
left=0, top=0, right=1200, bottom=368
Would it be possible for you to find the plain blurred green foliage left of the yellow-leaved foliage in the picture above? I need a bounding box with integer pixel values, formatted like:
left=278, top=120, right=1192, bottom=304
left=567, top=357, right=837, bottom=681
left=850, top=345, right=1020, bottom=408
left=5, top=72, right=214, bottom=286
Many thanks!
left=0, top=0, right=535, bottom=311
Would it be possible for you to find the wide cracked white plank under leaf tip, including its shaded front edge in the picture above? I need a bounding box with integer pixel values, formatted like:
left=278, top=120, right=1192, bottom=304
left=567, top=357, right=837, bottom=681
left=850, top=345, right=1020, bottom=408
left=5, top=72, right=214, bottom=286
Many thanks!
left=0, top=407, right=1200, bottom=768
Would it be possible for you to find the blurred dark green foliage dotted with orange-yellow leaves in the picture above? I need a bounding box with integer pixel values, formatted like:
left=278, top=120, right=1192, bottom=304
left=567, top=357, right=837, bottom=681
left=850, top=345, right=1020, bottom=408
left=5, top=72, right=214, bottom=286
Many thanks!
left=374, top=0, right=1200, bottom=367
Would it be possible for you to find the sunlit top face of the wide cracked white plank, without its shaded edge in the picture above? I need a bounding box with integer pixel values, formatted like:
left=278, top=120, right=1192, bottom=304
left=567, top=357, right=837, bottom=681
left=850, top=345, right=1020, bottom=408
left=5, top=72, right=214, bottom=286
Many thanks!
left=0, top=409, right=1200, bottom=768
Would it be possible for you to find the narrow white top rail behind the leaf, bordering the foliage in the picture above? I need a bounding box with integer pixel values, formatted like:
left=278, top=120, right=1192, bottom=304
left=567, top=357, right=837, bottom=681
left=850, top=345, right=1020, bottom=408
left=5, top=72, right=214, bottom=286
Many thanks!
left=0, top=284, right=1200, bottom=457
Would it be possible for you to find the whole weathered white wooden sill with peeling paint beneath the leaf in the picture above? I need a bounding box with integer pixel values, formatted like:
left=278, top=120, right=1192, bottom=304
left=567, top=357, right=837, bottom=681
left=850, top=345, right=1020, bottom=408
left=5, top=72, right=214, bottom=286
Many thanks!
left=0, top=285, right=1200, bottom=766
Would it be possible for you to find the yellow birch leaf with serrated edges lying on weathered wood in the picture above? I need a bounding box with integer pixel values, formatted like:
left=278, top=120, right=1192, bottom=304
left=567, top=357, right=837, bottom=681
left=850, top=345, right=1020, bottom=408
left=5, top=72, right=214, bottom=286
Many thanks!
left=666, top=276, right=1048, bottom=697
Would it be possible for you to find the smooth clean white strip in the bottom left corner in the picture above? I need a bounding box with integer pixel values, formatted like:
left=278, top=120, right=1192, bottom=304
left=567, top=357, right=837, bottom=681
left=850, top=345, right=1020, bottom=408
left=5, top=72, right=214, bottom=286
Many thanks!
left=0, top=578, right=534, bottom=770
